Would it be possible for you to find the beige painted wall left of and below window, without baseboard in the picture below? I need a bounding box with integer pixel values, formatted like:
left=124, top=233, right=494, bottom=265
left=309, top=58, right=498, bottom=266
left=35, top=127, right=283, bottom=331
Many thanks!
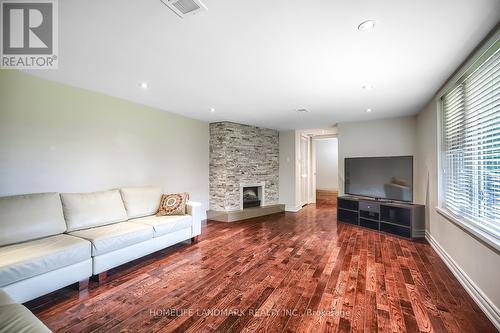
left=416, top=99, right=500, bottom=311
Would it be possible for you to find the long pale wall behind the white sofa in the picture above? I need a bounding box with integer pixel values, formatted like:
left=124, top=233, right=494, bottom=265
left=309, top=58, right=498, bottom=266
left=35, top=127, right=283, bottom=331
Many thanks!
left=0, top=70, right=208, bottom=215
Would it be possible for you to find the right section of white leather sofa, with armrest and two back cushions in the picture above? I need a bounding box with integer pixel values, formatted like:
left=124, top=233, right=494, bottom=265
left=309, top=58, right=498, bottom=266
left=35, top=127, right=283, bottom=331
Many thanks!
left=61, top=188, right=201, bottom=275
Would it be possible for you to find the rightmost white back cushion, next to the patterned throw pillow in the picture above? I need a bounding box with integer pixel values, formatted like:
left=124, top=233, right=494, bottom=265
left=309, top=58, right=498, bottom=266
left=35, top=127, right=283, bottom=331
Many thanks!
left=120, top=187, right=162, bottom=219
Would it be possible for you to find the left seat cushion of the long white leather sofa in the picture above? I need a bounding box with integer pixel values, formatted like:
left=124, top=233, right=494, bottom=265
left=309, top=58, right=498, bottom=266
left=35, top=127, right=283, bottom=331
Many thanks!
left=0, top=235, right=90, bottom=287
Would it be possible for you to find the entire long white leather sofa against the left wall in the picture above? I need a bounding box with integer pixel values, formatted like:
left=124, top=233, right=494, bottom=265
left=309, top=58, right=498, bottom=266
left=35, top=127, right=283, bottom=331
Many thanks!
left=0, top=187, right=201, bottom=303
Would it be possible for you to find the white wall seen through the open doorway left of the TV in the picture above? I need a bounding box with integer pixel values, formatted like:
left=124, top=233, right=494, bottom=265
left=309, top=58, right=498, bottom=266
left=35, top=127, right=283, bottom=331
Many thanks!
left=314, top=138, right=339, bottom=191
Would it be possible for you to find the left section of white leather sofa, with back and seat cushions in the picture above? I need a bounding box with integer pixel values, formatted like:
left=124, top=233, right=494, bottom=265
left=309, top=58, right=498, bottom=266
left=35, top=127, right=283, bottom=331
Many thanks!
left=0, top=193, right=92, bottom=303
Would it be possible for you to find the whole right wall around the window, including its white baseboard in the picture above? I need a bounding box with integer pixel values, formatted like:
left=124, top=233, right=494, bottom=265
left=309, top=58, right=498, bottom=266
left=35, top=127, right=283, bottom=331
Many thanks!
left=415, top=29, right=500, bottom=330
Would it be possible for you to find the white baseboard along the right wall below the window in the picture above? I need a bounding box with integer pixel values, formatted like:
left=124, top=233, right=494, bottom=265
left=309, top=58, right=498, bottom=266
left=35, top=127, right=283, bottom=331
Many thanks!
left=425, top=230, right=500, bottom=331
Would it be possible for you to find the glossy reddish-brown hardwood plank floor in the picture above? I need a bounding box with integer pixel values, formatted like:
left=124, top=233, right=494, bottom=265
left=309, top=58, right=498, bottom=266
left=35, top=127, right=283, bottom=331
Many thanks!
left=27, top=206, right=496, bottom=333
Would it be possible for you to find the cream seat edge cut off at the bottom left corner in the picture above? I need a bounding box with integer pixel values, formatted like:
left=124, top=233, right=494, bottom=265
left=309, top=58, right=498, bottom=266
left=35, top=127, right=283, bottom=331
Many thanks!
left=0, top=304, right=52, bottom=333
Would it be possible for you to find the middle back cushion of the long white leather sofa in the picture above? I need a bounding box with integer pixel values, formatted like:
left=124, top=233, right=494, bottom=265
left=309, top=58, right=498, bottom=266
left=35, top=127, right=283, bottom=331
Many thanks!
left=61, top=190, right=127, bottom=232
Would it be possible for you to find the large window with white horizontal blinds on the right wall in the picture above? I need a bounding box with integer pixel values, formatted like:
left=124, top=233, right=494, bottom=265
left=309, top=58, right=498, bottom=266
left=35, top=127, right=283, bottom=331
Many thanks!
left=441, top=43, right=500, bottom=239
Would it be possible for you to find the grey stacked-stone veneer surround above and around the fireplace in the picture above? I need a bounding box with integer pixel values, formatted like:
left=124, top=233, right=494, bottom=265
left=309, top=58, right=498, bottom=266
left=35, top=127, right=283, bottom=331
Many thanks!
left=209, top=122, right=279, bottom=211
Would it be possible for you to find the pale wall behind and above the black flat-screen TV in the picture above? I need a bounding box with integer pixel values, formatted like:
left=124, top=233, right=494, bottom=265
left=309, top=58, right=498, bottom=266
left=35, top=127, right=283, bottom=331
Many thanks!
left=337, top=116, right=416, bottom=195
